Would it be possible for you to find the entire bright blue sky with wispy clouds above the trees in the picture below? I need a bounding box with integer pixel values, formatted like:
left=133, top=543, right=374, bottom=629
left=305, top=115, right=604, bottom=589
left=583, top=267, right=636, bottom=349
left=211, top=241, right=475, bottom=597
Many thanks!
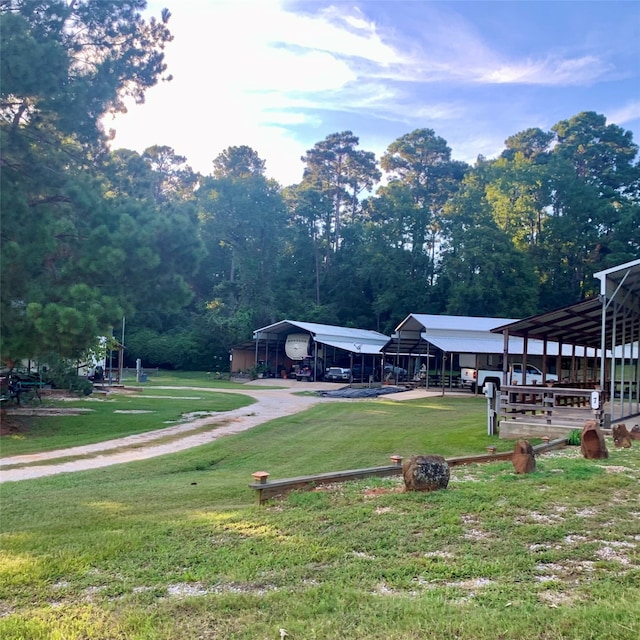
left=105, top=0, right=640, bottom=186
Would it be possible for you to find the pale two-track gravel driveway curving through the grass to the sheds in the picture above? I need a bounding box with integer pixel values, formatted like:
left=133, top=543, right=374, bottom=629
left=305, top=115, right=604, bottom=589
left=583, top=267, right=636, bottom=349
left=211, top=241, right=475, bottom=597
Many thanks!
left=0, top=382, right=344, bottom=482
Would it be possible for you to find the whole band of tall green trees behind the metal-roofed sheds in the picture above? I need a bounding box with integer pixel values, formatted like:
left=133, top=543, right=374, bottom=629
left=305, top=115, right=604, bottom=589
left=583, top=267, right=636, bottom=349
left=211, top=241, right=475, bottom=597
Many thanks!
left=0, top=0, right=640, bottom=369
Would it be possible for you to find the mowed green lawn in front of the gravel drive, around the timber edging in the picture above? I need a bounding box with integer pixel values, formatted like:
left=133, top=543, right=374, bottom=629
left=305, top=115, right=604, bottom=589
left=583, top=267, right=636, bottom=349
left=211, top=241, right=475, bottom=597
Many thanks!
left=0, top=390, right=640, bottom=640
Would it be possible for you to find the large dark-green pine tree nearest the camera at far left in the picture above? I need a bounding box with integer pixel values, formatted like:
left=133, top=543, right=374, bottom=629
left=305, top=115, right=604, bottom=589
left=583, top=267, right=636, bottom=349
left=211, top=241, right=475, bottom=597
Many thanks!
left=0, top=0, right=179, bottom=361
